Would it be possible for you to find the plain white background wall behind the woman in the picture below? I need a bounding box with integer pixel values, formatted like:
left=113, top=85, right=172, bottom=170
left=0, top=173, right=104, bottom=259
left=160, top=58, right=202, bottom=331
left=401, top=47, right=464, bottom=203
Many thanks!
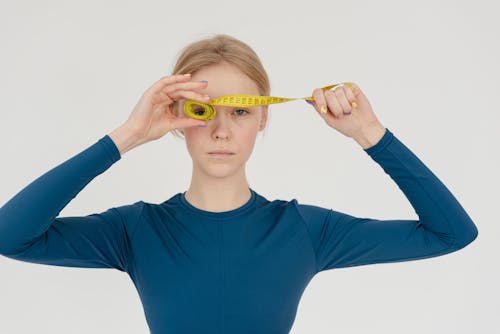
left=0, top=0, right=500, bottom=334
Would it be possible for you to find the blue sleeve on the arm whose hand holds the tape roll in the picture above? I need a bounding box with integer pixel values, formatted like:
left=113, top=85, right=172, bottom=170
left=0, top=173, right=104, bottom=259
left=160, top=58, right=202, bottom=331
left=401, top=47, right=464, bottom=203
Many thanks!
left=0, top=135, right=144, bottom=271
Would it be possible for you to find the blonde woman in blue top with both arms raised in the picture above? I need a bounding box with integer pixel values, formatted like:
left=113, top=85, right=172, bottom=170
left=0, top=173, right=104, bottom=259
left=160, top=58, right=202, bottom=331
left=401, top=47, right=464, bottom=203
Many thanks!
left=0, top=35, right=478, bottom=333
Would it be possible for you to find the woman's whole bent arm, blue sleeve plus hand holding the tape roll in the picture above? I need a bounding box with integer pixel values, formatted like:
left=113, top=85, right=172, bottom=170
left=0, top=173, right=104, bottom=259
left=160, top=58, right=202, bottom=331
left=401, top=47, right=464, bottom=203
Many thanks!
left=0, top=75, right=214, bottom=271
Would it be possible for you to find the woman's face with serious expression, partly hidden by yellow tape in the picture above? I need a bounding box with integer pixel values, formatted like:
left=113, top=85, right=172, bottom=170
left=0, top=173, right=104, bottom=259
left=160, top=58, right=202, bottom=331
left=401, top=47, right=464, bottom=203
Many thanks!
left=179, top=63, right=268, bottom=178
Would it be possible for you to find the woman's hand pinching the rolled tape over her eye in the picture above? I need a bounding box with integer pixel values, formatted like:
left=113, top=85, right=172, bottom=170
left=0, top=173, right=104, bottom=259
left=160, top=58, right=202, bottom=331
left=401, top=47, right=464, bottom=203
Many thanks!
left=123, top=74, right=210, bottom=144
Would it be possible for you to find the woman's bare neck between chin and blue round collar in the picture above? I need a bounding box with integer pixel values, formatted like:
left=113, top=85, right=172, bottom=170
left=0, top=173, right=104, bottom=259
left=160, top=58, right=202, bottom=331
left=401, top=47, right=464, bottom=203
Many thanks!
left=184, top=169, right=252, bottom=212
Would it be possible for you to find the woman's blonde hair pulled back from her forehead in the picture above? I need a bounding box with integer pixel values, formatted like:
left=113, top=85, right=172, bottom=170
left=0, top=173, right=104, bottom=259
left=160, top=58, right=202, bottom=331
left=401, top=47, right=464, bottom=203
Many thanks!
left=168, top=34, right=271, bottom=138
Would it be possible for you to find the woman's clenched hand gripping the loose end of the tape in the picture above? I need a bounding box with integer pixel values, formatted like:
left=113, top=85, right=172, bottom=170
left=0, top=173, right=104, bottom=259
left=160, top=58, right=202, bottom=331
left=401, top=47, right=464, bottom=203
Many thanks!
left=309, top=83, right=381, bottom=139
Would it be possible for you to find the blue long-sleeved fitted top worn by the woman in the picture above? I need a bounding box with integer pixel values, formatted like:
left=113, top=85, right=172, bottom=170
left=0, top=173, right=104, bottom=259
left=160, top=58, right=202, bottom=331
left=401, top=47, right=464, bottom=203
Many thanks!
left=0, top=128, right=478, bottom=334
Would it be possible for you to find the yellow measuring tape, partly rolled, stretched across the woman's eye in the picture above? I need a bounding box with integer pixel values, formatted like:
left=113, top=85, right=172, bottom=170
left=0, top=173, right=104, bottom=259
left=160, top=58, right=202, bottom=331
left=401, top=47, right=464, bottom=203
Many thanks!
left=184, top=82, right=357, bottom=121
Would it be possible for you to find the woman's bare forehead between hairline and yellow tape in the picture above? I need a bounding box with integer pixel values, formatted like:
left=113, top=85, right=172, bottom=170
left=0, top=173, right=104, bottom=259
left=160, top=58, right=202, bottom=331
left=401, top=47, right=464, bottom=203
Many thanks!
left=191, top=63, right=260, bottom=98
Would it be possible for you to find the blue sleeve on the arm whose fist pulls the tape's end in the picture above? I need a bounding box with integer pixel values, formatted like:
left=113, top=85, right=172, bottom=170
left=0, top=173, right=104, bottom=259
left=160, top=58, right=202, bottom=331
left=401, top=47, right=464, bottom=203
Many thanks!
left=295, top=128, right=478, bottom=272
